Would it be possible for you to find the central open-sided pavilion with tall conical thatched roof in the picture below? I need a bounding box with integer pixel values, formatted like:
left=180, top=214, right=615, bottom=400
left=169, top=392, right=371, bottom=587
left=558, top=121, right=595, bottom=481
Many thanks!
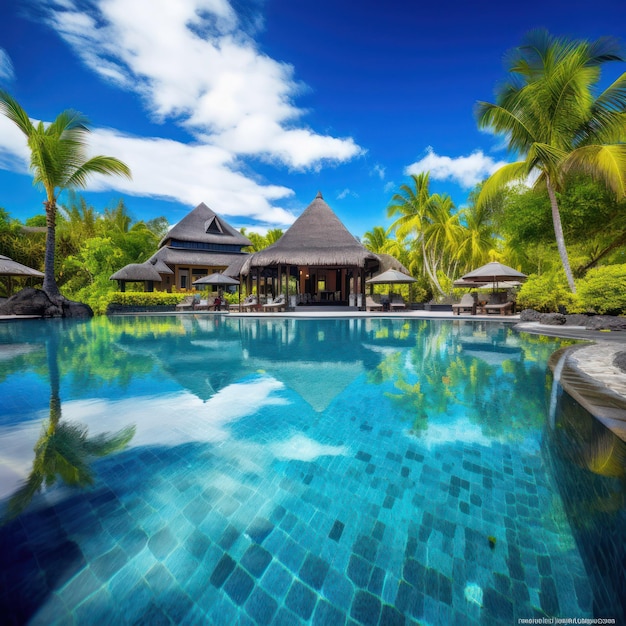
left=236, top=193, right=398, bottom=307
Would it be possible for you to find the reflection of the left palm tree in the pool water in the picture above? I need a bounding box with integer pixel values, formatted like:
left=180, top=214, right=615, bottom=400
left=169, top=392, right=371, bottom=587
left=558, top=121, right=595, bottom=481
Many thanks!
left=2, top=324, right=135, bottom=523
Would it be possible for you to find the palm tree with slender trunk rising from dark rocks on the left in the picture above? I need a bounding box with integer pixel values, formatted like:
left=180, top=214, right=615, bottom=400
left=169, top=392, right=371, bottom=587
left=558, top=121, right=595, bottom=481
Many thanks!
left=0, top=90, right=130, bottom=301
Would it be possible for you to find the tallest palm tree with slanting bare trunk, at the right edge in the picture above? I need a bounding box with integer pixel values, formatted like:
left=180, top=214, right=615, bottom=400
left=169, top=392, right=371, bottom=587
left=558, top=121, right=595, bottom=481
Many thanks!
left=476, top=30, right=626, bottom=292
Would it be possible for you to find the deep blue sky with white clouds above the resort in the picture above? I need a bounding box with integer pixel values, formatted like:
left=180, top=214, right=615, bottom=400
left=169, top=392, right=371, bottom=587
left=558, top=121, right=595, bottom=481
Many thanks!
left=0, top=0, right=626, bottom=236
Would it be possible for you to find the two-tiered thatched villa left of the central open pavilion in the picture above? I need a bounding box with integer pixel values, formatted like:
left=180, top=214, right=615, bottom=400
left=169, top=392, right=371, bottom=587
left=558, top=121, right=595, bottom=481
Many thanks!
left=111, top=203, right=250, bottom=292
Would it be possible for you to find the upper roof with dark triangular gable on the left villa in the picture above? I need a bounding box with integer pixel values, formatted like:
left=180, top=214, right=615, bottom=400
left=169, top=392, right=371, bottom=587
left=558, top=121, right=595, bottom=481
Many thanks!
left=159, top=202, right=251, bottom=247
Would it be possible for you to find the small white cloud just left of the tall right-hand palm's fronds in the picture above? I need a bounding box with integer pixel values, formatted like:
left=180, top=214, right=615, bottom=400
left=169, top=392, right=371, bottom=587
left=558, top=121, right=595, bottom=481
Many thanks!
left=404, top=146, right=507, bottom=189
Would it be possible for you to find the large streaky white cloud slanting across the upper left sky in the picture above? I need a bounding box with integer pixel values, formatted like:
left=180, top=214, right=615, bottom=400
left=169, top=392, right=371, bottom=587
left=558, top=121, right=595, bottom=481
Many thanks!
left=42, top=0, right=361, bottom=169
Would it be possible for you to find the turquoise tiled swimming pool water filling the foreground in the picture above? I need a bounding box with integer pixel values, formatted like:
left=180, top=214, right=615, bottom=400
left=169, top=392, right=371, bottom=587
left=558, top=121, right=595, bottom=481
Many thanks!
left=0, top=316, right=626, bottom=626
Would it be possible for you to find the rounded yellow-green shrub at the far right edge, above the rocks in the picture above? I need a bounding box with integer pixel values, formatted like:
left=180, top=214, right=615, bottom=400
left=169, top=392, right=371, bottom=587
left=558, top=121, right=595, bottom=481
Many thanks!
left=578, top=264, right=626, bottom=315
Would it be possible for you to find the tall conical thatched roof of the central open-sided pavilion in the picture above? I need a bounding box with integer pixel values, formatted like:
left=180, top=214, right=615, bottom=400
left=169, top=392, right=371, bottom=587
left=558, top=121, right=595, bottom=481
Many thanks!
left=242, top=193, right=379, bottom=274
